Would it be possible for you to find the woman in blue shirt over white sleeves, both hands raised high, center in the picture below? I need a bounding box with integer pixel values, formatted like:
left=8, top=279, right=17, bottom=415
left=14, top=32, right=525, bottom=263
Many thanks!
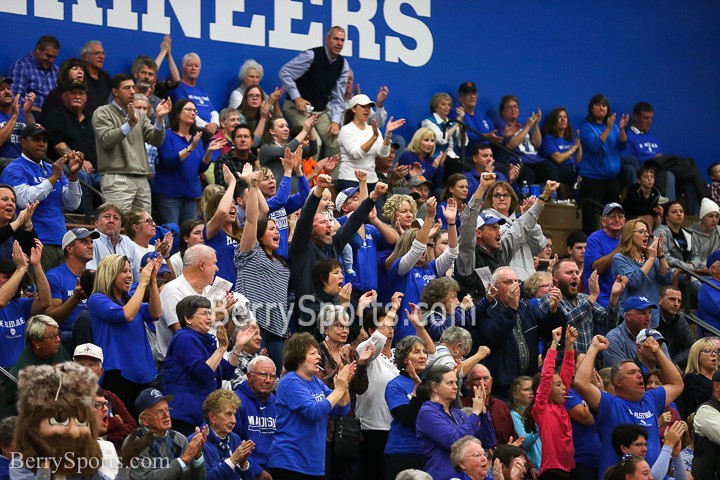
left=385, top=198, right=458, bottom=341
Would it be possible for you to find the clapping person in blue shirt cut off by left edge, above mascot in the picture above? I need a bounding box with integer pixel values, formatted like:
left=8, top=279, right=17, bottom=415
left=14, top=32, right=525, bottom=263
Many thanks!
left=0, top=240, right=54, bottom=369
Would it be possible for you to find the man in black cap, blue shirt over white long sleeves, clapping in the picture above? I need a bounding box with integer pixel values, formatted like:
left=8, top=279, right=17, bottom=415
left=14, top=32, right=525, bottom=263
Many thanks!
left=0, top=124, right=82, bottom=270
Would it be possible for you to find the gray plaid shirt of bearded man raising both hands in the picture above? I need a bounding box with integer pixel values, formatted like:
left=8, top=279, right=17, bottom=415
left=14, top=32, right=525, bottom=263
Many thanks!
left=538, top=293, right=619, bottom=353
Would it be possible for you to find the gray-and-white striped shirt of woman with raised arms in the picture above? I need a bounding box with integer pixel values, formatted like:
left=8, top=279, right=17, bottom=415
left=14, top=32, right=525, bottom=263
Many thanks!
left=235, top=243, right=290, bottom=337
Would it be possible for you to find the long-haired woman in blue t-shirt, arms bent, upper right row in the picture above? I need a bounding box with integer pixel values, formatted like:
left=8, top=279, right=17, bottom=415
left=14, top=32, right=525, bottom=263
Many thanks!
left=540, top=107, right=582, bottom=185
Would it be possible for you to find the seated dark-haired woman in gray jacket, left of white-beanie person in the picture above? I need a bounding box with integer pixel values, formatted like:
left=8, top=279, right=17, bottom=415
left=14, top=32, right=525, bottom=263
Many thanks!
left=653, top=202, right=702, bottom=295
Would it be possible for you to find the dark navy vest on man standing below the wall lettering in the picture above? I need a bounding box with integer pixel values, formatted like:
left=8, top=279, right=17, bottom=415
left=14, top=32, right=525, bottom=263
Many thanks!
left=295, top=47, right=345, bottom=111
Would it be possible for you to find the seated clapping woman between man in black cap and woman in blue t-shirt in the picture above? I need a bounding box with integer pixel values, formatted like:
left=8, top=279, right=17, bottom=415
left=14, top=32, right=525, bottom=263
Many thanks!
left=497, top=95, right=559, bottom=185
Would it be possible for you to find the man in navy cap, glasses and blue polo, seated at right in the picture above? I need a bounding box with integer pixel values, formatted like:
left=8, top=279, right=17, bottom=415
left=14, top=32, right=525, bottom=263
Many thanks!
left=583, top=202, right=625, bottom=308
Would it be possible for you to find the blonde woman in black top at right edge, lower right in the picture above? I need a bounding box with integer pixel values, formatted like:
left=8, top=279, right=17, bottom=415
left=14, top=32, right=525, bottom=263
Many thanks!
left=682, top=338, right=720, bottom=417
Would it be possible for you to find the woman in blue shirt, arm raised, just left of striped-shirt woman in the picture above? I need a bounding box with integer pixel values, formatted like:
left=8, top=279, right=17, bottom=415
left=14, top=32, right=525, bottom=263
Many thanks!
left=203, top=165, right=242, bottom=288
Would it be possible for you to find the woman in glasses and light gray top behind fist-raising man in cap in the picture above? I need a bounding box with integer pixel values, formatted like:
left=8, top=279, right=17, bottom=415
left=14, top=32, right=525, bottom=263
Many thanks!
left=483, top=181, right=560, bottom=281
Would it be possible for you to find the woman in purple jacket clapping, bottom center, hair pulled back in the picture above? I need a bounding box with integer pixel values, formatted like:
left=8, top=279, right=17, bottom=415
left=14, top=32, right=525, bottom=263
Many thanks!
left=416, top=366, right=495, bottom=478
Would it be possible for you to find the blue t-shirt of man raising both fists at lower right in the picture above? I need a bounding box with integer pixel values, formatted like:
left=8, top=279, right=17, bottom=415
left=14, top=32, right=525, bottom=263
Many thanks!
left=596, top=387, right=665, bottom=479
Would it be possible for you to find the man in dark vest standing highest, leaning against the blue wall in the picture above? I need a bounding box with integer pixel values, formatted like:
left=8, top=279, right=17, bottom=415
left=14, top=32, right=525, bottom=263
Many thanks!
left=279, top=26, right=350, bottom=158
